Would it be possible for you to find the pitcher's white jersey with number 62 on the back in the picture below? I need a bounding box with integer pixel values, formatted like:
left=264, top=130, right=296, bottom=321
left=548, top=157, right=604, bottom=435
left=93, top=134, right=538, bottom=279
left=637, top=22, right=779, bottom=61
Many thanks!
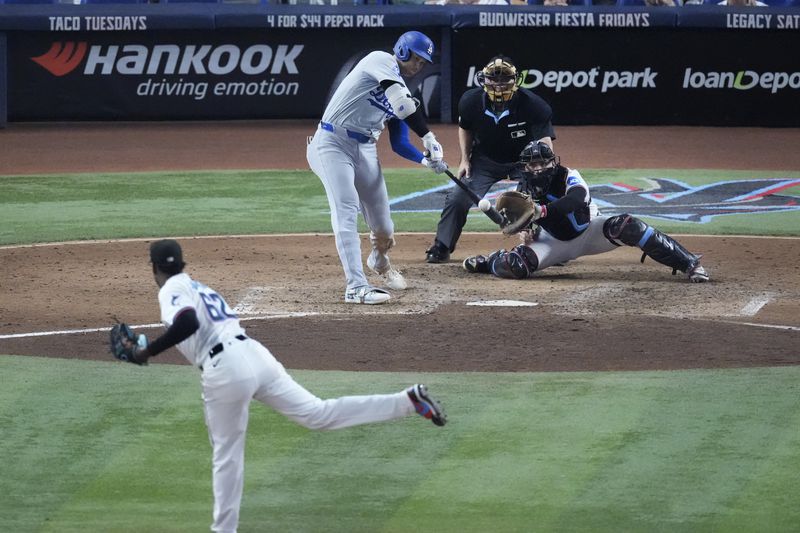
left=158, top=273, right=244, bottom=366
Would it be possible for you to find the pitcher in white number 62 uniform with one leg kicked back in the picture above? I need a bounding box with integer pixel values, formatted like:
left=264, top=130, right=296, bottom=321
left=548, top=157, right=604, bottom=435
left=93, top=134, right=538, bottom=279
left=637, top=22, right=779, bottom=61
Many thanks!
left=112, top=239, right=447, bottom=532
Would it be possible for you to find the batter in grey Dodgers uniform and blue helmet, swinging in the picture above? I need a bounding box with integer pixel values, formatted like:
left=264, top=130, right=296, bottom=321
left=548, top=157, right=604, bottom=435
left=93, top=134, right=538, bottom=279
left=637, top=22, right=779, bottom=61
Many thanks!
left=306, top=31, right=447, bottom=304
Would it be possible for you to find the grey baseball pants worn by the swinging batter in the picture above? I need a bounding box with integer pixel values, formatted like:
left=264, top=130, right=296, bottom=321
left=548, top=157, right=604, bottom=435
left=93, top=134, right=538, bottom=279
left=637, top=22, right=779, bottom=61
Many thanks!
left=306, top=129, right=394, bottom=289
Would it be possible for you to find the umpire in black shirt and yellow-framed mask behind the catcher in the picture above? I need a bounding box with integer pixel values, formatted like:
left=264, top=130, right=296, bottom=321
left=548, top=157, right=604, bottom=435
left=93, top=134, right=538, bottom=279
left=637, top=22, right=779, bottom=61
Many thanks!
left=426, top=56, right=556, bottom=263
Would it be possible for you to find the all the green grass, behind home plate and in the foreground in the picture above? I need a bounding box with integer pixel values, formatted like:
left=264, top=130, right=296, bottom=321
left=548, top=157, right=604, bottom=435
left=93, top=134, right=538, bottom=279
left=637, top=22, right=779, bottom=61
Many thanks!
left=0, top=170, right=800, bottom=533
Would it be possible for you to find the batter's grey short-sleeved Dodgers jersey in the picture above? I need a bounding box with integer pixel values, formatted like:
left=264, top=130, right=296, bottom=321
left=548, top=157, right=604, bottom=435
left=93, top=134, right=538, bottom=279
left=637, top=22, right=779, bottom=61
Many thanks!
left=322, top=51, right=406, bottom=140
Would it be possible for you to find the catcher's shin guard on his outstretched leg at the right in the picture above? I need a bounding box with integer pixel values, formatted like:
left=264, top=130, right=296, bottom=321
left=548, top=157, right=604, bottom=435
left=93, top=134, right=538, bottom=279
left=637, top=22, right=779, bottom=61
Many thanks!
left=603, top=215, right=700, bottom=274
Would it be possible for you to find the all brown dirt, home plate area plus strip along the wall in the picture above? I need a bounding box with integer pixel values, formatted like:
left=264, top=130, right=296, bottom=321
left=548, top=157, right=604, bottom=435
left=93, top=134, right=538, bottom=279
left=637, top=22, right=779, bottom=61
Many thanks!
left=0, top=122, right=800, bottom=371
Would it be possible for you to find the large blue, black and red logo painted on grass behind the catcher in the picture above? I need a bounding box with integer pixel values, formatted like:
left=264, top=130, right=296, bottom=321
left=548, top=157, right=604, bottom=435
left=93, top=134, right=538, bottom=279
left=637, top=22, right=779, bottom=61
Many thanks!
left=391, top=178, right=800, bottom=224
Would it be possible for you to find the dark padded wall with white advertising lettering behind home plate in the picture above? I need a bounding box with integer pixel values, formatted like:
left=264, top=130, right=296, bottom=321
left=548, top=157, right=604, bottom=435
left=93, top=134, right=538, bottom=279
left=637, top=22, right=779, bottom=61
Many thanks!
left=0, top=4, right=800, bottom=127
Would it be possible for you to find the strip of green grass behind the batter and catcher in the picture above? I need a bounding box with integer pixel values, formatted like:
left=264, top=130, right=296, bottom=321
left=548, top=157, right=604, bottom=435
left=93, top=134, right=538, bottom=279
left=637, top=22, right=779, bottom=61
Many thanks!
left=0, top=170, right=800, bottom=245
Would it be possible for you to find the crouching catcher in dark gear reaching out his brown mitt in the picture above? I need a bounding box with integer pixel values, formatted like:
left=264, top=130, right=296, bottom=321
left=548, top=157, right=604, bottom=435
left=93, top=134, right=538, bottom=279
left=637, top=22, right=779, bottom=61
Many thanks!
left=463, top=141, right=709, bottom=283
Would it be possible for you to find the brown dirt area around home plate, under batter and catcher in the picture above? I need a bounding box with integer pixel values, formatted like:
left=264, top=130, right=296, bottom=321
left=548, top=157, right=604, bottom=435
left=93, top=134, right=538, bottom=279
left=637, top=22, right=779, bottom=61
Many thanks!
left=0, top=234, right=800, bottom=371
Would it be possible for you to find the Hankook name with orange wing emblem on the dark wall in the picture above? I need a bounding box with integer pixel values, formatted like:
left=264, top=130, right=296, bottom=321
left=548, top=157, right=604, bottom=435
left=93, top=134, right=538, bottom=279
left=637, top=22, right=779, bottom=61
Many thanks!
left=31, top=41, right=304, bottom=77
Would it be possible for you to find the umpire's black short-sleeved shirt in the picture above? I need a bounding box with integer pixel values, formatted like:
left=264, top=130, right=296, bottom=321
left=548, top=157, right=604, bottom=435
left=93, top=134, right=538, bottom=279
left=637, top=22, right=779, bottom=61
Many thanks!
left=458, top=87, right=556, bottom=163
